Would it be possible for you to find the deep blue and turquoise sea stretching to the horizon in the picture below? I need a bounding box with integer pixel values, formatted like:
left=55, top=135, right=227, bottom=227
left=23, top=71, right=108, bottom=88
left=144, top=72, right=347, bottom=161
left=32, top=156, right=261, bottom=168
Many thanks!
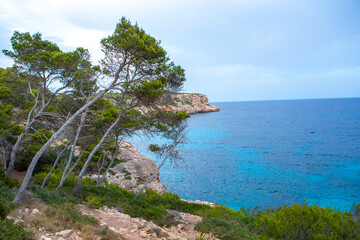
left=133, top=98, right=360, bottom=210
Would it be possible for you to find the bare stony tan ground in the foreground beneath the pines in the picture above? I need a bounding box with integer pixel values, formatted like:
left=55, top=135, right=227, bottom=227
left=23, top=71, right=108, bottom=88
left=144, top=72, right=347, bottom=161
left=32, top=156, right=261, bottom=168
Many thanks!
left=8, top=205, right=215, bottom=240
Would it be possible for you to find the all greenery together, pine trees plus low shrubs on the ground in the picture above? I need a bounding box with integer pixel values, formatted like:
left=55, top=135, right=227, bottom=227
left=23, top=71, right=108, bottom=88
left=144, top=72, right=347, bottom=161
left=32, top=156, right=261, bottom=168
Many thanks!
left=0, top=18, right=360, bottom=239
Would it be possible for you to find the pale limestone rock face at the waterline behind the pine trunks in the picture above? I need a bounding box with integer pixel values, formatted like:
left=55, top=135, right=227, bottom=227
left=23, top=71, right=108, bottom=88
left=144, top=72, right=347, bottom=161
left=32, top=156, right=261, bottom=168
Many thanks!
left=102, top=142, right=168, bottom=193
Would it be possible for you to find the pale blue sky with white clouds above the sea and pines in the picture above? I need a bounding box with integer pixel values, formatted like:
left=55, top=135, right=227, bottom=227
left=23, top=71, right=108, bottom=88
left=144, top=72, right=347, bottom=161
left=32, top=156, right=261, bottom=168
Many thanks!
left=0, top=0, right=360, bottom=102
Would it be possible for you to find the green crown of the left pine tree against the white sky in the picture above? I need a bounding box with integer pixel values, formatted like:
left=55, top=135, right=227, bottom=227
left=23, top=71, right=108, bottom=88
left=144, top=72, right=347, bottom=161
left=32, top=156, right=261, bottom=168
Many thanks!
left=3, top=31, right=94, bottom=91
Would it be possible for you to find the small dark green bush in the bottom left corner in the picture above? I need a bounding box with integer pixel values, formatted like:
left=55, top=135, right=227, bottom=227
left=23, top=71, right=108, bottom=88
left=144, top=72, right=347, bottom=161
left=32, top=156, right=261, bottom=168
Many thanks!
left=0, top=220, right=34, bottom=240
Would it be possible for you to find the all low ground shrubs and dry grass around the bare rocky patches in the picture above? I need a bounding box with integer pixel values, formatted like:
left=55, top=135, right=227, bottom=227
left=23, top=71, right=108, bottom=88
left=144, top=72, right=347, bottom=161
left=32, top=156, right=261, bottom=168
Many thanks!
left=0, top=170, right=360, bottom=239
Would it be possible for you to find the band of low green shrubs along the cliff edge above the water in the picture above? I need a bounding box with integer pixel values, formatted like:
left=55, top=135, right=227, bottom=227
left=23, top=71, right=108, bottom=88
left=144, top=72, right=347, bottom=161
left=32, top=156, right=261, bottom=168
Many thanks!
left=14, top=172, right=360, bottom=239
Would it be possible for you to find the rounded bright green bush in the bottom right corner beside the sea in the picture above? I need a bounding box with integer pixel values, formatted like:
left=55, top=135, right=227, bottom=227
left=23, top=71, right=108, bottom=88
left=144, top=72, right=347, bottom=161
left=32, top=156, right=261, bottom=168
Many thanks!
left=256, top=204, right=360, bottom=240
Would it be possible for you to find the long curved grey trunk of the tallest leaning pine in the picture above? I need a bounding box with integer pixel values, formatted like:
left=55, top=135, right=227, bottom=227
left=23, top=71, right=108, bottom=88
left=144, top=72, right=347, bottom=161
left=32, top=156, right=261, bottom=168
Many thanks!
left=12, top=88, right=108, bottom=204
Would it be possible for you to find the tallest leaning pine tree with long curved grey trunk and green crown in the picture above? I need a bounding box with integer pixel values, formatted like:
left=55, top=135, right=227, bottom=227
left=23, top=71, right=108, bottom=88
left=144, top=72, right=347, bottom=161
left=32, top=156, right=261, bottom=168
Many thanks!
left=7, top=18, right=185, bottom=203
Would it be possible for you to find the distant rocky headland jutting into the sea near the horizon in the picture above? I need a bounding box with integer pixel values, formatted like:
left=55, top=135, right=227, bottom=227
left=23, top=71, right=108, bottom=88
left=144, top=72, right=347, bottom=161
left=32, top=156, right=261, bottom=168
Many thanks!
left=160, top=93, right=220, bottom=114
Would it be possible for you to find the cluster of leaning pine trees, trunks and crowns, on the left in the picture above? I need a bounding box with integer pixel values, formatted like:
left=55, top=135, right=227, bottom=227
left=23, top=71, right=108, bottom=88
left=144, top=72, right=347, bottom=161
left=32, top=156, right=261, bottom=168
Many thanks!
left=0, top=18, right=189, bottom=203
